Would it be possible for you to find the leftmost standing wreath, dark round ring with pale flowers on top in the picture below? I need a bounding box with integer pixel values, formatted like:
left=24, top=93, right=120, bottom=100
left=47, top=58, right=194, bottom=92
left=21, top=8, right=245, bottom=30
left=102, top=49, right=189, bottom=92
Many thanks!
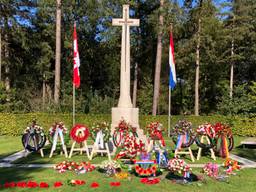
left=21, top=121, right=46, bottom=152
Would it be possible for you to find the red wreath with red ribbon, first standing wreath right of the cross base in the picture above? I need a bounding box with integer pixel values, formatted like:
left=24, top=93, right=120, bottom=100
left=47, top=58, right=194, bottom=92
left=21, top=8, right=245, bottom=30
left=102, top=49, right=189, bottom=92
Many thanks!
left=146, top=122, right=165, bottom=146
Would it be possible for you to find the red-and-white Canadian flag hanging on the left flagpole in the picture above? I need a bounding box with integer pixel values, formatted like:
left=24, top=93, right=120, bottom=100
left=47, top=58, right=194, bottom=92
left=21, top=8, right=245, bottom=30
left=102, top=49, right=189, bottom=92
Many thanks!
left=73, top=23, right=80, bottom=88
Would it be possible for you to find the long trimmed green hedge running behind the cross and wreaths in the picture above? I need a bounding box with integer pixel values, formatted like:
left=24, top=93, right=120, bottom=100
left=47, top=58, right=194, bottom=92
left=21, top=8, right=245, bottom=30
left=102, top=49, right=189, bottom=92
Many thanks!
left=0, top=113, right=256, bottom=136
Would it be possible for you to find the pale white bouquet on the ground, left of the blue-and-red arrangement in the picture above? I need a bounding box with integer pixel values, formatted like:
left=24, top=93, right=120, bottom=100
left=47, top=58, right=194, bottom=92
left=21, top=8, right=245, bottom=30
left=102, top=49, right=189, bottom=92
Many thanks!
left=100, top=160, right=121, bottom=177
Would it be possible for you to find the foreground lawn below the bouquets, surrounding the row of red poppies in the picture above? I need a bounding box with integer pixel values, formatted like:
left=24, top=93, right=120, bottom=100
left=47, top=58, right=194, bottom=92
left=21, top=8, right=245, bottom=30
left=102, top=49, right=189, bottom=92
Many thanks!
left=0, top=168, right=256, bottom=192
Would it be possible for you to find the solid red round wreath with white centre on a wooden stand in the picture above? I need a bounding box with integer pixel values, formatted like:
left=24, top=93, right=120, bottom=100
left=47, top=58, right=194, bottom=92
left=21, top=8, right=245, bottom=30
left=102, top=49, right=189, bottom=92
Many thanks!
left=70, top=124, right=90, bottom=143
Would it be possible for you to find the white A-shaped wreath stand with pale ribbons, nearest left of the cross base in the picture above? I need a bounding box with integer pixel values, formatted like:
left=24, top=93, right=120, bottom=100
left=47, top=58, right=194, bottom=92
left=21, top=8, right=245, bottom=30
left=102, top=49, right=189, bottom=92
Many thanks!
left=89, top=131, right=111, bottom=160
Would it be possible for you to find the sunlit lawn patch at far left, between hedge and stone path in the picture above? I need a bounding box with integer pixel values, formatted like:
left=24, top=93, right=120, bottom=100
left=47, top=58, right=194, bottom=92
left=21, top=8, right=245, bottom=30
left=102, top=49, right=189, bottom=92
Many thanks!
left=0, top=136, right=23, bottom=158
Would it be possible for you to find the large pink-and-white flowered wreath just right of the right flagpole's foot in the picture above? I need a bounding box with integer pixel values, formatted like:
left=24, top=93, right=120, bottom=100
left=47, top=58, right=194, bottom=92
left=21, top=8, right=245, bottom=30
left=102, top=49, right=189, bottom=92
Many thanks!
left=170, top=120, right=195, bottom=148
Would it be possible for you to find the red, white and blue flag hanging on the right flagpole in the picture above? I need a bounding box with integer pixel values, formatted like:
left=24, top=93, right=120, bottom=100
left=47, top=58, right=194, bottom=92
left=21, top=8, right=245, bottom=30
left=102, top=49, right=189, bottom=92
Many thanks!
left=169, top=33, right=176, bottom=89
